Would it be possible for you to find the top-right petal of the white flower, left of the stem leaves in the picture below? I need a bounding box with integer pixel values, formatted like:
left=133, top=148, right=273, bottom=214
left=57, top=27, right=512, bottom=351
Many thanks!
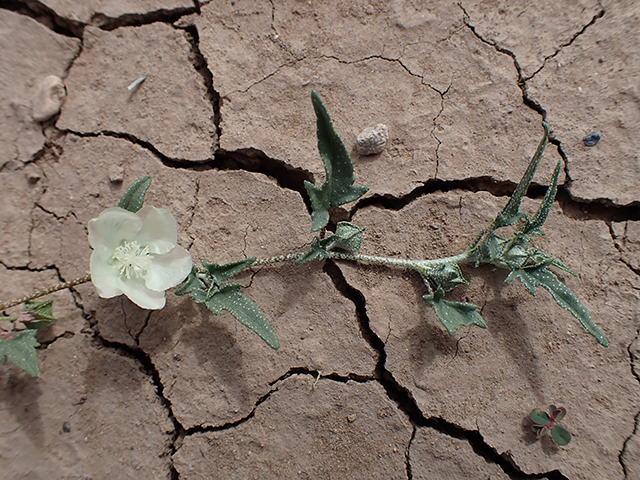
left=136, top=207, right=178, bottom=255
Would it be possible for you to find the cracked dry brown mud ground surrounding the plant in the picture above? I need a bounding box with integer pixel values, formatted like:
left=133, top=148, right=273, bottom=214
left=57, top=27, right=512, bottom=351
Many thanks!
left=0, top=0, right=640, bottom=479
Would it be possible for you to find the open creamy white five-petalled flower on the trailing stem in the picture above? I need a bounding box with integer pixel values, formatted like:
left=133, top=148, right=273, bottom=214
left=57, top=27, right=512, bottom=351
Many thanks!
left=88, top=207, right=192, bottom=310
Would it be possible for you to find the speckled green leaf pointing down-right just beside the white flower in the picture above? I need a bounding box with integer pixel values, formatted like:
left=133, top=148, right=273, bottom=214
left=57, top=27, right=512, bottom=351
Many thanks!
left=204, top=284, right=280, bottom=350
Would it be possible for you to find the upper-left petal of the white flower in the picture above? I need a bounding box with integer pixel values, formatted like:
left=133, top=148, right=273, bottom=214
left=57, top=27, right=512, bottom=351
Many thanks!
left=87, top=207, right=142, bottom=253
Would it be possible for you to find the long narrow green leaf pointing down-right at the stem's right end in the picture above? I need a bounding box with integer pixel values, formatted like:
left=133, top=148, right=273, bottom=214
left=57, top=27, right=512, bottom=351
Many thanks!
left=507, top=266, right=609, bottom=347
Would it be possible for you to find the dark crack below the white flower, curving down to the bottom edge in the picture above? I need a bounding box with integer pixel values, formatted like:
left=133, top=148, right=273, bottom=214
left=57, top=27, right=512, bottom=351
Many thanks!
left=83, top=332, right=185, bottom=479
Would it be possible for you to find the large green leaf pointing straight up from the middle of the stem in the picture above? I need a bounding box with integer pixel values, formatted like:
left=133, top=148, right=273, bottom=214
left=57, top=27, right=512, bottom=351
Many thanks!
left=304, top=90, right=369, bottom=232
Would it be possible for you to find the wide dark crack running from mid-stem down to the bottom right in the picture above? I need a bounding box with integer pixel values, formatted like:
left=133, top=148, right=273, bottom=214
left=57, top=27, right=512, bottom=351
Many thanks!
left=323, top=260, right=566, bottom=480
